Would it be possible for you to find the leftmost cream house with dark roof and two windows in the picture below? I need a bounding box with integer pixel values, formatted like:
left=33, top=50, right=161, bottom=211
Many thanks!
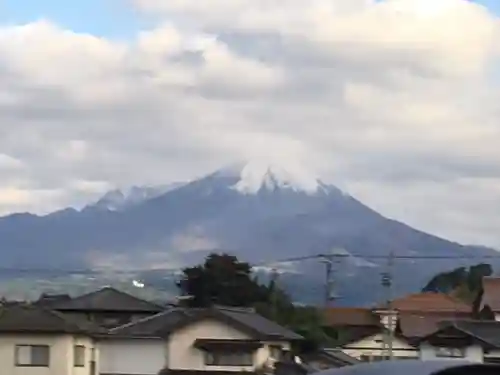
left=0, top=304, right=99, bottom=375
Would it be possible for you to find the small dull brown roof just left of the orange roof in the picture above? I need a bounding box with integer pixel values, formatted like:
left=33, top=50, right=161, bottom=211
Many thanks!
left=323, top=307, right=381, bottom=327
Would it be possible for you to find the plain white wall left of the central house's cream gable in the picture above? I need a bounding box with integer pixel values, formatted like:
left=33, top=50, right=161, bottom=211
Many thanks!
left=99, top=339, right=167, bottom=375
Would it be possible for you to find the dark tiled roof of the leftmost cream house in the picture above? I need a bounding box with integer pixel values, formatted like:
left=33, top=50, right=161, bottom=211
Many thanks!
left=0, top=304, right=99, bottom=334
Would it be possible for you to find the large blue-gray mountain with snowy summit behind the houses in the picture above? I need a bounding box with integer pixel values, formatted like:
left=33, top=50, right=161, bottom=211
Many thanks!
left=0, top=162, right=498, bottom=304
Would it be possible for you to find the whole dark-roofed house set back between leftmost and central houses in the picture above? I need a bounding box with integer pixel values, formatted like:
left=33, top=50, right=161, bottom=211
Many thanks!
left=43, top=287, right=165, bottom=328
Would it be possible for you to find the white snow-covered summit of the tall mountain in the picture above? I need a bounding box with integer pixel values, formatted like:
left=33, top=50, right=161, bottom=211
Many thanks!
left=226, top=161, right=326, bottom=194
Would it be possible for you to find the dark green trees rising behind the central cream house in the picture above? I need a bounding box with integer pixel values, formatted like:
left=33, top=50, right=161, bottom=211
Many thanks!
left=177, top=253, right=331, bottom=352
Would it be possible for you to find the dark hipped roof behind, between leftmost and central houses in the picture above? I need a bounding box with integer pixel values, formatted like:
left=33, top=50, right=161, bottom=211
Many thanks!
left=50, top=287, right=164, bottom=313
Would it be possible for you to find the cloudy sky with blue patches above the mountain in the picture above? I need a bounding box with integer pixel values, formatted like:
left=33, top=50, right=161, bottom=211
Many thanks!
left=0, top=0, right=500, bottom=248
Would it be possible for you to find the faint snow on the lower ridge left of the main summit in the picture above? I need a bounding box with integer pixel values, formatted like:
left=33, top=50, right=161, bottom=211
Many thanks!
left=88, top=183, right=183, bottom=211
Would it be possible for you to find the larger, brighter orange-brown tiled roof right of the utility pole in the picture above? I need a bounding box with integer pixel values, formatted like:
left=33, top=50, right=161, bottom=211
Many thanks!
left=378, top=292, right=472, bottom=313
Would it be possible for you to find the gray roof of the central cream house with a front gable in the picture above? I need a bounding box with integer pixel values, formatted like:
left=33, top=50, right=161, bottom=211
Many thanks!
left=109, top=307, right=302, bottom=340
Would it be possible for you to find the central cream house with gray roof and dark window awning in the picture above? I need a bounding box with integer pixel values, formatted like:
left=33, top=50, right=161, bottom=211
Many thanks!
left=99, top=307, right=302, bottom=375
